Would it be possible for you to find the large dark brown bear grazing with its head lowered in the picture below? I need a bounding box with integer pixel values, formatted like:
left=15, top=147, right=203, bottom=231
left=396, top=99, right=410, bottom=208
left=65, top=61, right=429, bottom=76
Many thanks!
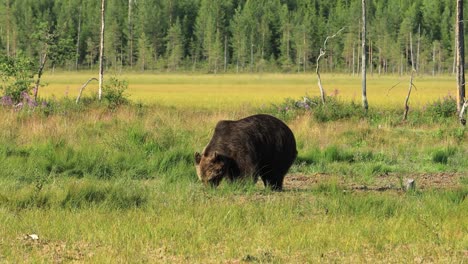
left=195, top=114, right=297, bottom=190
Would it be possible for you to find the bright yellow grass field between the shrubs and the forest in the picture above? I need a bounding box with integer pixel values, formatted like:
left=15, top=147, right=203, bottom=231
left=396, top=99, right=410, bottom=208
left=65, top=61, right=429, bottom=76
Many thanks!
left=39, top=72, right=456, bottom=109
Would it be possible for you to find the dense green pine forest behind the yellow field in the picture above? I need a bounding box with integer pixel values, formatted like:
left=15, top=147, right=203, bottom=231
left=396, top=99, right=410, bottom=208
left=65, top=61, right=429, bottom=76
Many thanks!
left=0, top=0, right=464, bottom=74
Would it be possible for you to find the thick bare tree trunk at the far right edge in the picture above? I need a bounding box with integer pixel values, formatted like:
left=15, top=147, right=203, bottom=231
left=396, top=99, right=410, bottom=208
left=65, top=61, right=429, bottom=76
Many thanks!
left=455, top=0, right=465, bottom=113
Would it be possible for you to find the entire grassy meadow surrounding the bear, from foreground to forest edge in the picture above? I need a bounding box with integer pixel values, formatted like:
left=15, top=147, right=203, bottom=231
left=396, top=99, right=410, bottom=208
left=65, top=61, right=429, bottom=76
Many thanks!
left=0, top=73, right=468, bottom=263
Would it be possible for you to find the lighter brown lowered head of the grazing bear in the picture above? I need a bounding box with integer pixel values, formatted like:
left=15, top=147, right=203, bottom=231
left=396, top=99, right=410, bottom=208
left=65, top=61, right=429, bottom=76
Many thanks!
left=195, top=151, right=228, bottom=187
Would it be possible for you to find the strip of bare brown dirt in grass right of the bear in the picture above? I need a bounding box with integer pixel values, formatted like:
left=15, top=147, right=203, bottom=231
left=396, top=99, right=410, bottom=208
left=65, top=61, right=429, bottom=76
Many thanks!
left=284, top=172, right=466, bottom=191
